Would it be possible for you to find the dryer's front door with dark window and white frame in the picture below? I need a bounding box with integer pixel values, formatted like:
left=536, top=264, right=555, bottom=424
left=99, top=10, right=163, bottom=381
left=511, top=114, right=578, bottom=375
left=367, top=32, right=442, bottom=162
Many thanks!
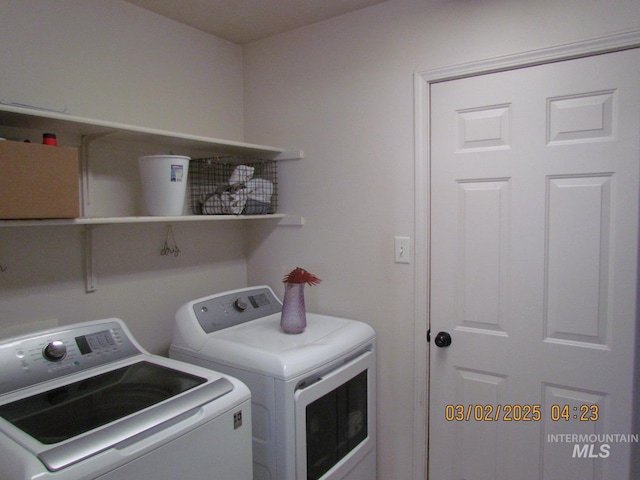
left=295, top=351, right=375, bottom=480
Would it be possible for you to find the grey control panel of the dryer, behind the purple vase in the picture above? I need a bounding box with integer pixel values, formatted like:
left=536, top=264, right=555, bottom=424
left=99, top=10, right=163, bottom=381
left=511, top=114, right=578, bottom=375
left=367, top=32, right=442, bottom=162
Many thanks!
left=191, top=286, right=282, bottom=333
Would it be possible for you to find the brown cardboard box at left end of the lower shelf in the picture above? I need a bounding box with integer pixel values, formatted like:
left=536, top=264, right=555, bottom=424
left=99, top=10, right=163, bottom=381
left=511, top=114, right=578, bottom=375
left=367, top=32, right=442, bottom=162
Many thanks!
left=0, top=141, right=80, bottom=219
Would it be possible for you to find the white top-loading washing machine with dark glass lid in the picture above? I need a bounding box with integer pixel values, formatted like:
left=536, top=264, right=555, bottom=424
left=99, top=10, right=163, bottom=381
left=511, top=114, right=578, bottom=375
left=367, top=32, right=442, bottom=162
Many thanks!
left=0, top=318, right=252, bottom=480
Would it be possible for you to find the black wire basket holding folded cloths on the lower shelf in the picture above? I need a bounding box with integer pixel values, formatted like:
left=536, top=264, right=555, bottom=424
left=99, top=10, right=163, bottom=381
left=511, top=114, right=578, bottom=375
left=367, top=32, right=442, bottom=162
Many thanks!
left=188, top=156, right=278, bottom=215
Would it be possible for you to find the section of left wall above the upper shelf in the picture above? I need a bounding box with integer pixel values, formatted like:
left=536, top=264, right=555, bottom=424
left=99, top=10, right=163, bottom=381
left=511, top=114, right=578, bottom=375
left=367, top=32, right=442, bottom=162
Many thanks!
left=0, top=0, right=243, bottom=140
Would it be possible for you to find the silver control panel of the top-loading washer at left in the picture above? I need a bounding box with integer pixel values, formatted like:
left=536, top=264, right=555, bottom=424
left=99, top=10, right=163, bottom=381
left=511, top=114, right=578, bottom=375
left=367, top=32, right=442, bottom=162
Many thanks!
left=0, top=319, right=141, bottom=395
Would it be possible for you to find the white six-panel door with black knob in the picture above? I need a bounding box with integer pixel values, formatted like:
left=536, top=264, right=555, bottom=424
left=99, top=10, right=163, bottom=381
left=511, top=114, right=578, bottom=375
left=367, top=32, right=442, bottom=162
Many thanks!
left=428, top=50, right=640, bottom=480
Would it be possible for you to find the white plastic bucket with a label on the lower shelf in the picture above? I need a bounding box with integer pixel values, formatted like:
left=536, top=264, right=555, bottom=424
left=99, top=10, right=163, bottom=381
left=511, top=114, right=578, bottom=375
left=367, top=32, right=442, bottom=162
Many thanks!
left=138, top=155, right=190, bottom=216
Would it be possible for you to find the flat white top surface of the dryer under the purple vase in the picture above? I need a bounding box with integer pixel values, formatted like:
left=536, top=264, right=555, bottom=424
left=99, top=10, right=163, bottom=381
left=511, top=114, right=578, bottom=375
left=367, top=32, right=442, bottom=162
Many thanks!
left=187, top=313, right=375, bottom=380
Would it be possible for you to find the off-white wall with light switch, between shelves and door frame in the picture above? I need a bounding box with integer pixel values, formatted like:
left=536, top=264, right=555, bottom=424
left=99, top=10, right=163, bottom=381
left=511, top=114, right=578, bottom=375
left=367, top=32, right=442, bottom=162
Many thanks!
left=244, top=0, right=640, bottom=480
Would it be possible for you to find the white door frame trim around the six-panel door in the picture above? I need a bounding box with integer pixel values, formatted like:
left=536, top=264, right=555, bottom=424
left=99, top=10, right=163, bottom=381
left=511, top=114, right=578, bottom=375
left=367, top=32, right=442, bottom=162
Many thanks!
left=413, top=30, right=640, bottom=480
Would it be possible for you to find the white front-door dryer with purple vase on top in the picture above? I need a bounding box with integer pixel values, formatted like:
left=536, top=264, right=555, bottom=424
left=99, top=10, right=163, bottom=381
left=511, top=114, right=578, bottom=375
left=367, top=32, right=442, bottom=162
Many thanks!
left=170, top=286, right=376, bottom=480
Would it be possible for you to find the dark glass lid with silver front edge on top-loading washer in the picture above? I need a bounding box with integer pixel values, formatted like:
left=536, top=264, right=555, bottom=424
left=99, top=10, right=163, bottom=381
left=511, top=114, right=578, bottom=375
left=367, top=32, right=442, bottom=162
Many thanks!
left=0, top=356, right=234, bottom=472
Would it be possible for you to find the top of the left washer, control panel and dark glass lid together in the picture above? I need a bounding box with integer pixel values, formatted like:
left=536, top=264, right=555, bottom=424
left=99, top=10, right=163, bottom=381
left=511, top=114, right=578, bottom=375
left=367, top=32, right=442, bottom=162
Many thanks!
left=0, top=318, right=240, bottom=472
